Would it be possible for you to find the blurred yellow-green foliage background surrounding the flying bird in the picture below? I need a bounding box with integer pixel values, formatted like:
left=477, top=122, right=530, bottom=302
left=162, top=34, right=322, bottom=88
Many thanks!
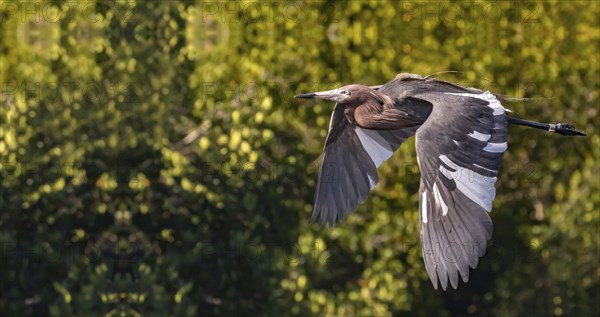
left=0, top=1, right=600, bottom=316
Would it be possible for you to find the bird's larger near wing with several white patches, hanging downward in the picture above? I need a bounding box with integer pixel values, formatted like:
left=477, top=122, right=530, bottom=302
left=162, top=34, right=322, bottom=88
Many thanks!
left=414, top=86, right=507, bottom=290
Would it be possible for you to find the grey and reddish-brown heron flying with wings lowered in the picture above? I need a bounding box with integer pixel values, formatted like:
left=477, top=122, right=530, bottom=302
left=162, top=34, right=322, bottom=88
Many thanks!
left=296, top=73, right=585, bottom=290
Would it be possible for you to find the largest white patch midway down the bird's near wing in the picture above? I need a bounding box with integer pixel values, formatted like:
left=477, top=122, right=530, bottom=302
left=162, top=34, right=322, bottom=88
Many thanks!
left=439, top=154, right=496, bottom=212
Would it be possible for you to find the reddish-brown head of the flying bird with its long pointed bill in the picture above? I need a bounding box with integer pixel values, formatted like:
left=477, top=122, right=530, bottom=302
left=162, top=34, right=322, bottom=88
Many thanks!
left=294, top=84, right=381, bottom=104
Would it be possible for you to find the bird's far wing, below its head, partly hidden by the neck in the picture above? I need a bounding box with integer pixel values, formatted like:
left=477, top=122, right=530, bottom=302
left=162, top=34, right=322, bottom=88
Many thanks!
left=310, top=104, right=417, bottom=227
